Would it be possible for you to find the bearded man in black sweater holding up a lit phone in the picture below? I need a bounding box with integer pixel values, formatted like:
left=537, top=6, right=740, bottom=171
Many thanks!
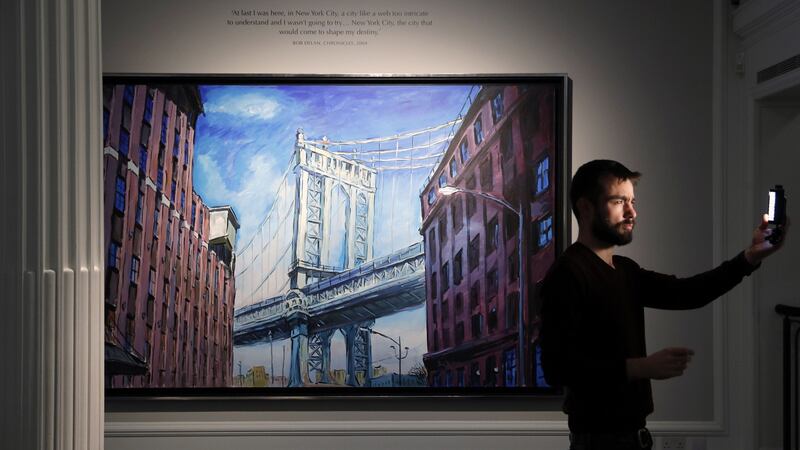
left=541, top=160, right=788, bottom=450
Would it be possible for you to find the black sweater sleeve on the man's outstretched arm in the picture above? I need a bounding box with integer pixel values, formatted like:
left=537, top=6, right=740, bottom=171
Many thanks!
left=627, top=252, right=758, bottom=310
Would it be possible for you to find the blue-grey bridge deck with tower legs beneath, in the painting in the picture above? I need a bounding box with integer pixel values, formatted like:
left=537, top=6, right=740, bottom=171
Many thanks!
left=233, top=242, right=425, bottom=386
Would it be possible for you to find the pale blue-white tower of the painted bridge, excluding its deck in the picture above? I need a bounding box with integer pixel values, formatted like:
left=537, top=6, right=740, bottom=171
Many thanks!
left=288, top=129, right=377, bottom=387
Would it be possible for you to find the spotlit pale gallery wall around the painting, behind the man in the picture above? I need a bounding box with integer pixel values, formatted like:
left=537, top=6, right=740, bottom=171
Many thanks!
left=102, top=0, right=724, bottom=448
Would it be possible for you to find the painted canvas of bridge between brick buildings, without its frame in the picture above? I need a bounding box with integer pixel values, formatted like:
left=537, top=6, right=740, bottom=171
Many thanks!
left=104, top=77, right=567, bottom=392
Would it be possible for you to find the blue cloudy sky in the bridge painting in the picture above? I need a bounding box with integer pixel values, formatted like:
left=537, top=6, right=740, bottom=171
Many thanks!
left=194, top=85, right=471, bottom=375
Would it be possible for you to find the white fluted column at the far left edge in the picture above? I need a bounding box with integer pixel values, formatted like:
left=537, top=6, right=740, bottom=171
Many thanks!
left=0, top=0, right=103, bottom=449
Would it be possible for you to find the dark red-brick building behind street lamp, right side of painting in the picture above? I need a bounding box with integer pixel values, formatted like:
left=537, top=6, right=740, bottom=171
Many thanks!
left=420, top=85, right=556, bottom=386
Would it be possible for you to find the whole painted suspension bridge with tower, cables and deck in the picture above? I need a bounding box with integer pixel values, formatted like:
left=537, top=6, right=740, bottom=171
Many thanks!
left=233, top=92, right=472, bottom=387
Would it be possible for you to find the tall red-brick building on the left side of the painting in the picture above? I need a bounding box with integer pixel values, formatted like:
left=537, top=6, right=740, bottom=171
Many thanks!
left=103, top=85, right=239, bottom=387
